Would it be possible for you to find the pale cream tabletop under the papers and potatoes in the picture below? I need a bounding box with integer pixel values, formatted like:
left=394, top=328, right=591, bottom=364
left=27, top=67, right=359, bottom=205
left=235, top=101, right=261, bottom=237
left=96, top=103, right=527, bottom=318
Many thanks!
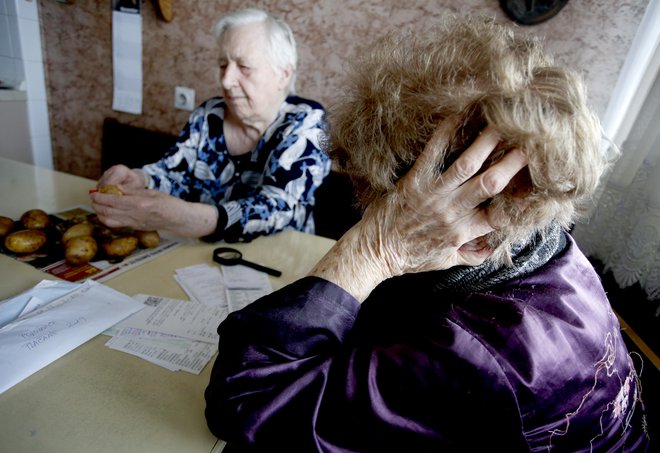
left=0, top=158, right=334, bottom=453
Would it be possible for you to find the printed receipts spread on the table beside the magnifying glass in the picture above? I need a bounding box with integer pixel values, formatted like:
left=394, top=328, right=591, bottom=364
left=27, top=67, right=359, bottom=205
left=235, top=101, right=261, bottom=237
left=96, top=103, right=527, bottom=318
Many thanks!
left=106, top=264, right=272, bottom=374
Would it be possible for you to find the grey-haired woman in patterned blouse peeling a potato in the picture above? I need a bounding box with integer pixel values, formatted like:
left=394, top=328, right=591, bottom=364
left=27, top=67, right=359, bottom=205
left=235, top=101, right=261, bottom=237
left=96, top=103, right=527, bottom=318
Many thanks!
left=90, top=9, right=330, bottom=242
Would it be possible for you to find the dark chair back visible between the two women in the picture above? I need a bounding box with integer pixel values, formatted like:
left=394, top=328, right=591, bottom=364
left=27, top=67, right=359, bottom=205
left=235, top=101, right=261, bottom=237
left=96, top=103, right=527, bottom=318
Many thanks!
left=314, top=170, right=361, bottom=239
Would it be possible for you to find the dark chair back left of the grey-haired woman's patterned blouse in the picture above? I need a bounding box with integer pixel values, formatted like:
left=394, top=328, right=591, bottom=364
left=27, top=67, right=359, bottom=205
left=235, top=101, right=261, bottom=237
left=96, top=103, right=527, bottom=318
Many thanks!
left=101, top=118, right=177, bottom=171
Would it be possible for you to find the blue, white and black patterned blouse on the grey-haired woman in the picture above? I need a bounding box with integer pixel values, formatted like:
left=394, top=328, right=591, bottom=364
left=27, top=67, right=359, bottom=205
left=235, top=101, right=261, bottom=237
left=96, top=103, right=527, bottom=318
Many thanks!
left=142, top=96, right=330, bottom=242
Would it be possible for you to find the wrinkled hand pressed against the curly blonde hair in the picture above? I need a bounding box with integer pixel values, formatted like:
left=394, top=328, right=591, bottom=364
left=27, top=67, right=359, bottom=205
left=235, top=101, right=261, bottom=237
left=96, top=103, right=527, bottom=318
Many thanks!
left=311, top=119, right=527, bottom=301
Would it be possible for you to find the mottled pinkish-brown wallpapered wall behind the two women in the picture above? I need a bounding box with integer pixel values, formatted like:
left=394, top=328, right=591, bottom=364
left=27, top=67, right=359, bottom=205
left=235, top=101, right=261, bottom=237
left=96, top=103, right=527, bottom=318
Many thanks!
left=39, top=0, right=648, bottom=178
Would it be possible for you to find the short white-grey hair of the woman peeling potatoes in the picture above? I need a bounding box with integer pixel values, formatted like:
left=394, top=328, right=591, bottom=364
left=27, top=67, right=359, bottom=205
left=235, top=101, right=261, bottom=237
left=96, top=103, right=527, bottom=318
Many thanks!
left=213, top=8, right=298, bottom=94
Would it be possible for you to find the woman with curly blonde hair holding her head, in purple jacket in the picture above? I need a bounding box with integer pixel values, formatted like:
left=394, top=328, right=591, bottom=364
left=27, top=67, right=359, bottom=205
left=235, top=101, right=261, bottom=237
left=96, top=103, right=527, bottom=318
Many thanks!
left=206, top=18, right=649, bottom=452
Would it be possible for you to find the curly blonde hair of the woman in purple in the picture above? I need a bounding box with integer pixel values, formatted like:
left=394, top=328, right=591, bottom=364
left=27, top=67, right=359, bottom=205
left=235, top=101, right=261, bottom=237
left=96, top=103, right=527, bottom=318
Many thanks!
left=328, top=16, right=607, bottom=263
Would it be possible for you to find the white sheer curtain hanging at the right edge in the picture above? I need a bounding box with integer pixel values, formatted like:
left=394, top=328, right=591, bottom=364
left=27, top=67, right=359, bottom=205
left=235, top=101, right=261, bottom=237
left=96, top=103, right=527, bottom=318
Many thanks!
left=573, top=0, right=660, bottom=304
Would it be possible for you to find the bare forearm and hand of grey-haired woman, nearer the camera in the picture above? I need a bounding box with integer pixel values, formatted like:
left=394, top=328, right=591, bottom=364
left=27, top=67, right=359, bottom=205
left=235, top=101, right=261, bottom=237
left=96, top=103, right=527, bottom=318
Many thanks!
left=90, top=186, right=217, bottom=237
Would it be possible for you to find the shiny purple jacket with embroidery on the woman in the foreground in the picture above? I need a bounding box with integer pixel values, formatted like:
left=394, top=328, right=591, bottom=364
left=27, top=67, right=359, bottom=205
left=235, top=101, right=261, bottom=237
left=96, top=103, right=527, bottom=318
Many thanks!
left=205, top=238, right=649, bottom=453
